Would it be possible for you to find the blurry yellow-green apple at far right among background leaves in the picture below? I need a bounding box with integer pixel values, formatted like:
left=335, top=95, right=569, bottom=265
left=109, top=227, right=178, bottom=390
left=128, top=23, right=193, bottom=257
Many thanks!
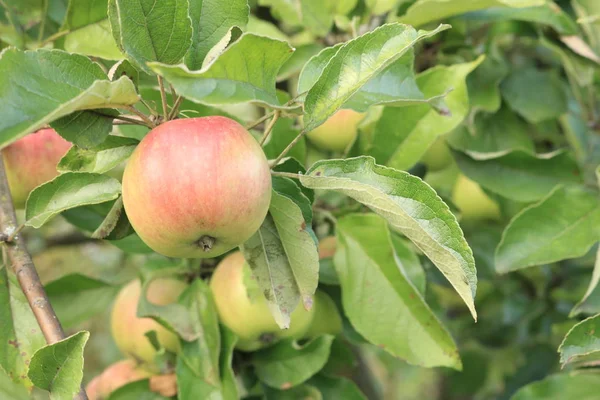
left=452, top=174, right=500, bottom=221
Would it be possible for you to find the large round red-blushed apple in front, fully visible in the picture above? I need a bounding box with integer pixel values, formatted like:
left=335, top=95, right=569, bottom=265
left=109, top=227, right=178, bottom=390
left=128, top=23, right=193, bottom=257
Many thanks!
left=123, top=116, right=271, bottom=258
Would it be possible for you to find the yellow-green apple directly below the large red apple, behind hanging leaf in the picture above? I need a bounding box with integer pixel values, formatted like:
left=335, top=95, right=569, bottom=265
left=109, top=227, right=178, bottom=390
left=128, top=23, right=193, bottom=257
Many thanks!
left=210, top=252, right=314, bottom=351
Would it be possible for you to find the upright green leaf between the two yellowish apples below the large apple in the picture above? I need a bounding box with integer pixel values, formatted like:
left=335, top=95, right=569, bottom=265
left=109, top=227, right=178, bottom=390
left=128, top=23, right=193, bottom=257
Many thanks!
left=176, top=279, right=221, bottom=399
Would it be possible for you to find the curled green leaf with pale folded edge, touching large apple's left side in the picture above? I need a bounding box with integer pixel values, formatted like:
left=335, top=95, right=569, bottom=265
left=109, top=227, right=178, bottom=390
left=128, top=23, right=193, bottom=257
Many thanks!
left=25, top=172, right=121, bottom=229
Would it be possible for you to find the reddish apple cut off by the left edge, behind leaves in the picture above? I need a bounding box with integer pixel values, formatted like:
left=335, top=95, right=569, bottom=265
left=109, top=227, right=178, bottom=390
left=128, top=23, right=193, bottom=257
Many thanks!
left=2, top=129, right=71, bottom=208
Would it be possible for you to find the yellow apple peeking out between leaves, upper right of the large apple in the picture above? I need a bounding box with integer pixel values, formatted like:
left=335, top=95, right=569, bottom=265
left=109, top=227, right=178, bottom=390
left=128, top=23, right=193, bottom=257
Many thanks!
left=306, top=109, right=366, bottom=152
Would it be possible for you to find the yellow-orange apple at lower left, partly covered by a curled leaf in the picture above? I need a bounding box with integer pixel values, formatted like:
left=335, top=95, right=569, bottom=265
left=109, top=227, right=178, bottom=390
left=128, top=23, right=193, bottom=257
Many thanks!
left=111, top=278, right=187, bottom=365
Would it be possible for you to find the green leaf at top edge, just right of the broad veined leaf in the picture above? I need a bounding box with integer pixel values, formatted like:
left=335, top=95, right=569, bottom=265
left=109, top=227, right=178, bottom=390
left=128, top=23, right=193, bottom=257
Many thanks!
left=185, top=0, right=250, bottom=71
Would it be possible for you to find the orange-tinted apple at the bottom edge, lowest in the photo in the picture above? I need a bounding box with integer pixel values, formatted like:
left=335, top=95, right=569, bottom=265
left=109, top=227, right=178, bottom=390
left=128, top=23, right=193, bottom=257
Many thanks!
left=85, top=360, right=151, bottom=400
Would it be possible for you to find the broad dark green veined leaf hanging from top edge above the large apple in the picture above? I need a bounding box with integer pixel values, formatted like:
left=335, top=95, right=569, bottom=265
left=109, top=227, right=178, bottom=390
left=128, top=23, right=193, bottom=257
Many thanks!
left=108, top=0, right=192, bottom=73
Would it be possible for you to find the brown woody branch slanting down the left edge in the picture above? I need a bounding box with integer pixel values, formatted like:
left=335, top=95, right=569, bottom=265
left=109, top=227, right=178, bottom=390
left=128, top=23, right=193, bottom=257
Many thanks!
left=0, top=153, right=87, bottom=400
